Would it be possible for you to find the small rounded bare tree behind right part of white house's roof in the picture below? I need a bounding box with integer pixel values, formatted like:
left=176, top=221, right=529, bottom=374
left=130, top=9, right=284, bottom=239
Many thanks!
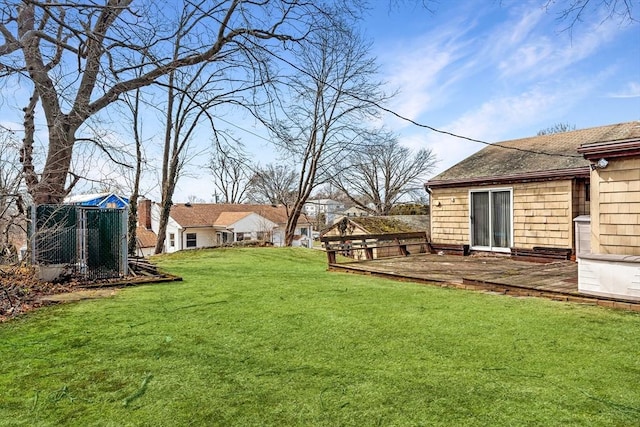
left=248, top=163, right=298, bottom=207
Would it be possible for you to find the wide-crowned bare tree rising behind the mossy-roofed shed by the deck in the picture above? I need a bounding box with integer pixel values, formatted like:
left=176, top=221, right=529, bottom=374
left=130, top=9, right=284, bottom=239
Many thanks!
left=332, top=132, right=436, bottom=215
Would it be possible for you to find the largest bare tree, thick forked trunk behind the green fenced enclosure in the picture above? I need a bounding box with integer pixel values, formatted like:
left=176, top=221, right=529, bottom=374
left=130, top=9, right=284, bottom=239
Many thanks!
left=0, top=0, right=340, bottom=207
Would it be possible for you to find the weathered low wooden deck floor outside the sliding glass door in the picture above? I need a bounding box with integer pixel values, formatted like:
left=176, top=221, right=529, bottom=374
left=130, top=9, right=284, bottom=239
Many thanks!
left=329, top=254, right=640, bottom=311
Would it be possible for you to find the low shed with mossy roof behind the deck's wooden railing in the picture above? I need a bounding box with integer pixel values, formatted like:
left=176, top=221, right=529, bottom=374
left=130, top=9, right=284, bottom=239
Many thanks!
left=322, top=215, right=429, bottom=259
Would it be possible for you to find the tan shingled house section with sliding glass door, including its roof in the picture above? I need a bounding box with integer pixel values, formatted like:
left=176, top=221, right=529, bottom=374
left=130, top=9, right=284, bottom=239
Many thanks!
left=425, top=122, right=640, bottom=253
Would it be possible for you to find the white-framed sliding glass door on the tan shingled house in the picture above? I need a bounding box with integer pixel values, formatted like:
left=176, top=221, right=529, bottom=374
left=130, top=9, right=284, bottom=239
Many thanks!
left=470, top=189, right=513, bottom=251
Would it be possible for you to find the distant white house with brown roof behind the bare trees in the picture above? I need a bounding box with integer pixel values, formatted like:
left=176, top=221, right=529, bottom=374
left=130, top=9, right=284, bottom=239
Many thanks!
left=138, top=200, right=313, bottom=252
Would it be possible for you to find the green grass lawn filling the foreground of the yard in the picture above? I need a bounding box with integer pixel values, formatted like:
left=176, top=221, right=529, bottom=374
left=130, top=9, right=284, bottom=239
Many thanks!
left=0, top=248, right=640, bottom=426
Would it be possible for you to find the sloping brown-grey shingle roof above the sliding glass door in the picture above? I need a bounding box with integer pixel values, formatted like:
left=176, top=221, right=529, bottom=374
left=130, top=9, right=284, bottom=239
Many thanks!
left=427, top=122, right=640, bottom=185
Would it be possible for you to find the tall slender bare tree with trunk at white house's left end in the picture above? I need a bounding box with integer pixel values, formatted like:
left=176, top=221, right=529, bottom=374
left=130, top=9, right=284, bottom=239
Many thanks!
left=149, top=0, right=356, bottom=253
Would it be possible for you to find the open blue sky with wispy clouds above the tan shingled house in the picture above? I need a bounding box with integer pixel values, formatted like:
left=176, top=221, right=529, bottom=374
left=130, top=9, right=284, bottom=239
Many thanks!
left=363, top=0, right=640, bottom=179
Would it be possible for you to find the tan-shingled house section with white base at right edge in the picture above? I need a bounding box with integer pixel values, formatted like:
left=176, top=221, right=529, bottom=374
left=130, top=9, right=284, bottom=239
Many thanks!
left=578, top=126, right=640, bottom=300
